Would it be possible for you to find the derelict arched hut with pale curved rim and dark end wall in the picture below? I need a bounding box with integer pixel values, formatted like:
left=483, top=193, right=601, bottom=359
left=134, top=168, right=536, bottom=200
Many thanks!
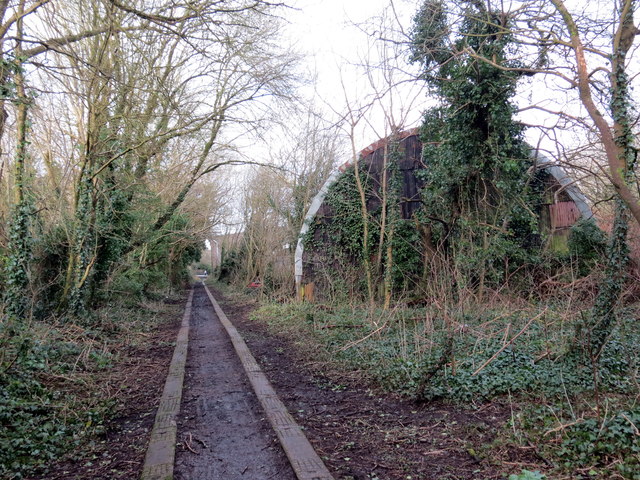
left=295, top=129, right=592, bottom=299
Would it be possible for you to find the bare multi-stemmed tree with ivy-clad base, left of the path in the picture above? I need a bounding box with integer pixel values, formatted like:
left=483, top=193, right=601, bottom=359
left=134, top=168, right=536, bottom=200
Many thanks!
left=0, top=0, right=296, bottom=314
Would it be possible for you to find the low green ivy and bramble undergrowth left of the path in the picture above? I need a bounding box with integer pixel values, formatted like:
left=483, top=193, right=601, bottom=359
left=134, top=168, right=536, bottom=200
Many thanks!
left=0, top=294, right=180, bottom=480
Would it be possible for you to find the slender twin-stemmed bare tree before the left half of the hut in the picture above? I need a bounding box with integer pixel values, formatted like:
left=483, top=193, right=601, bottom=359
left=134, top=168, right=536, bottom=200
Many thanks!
left=318, top=3, right=424, bottom=308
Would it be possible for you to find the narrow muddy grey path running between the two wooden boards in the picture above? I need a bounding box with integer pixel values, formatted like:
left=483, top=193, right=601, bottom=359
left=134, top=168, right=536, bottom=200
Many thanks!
left=174, top=284, right=296, bottom=480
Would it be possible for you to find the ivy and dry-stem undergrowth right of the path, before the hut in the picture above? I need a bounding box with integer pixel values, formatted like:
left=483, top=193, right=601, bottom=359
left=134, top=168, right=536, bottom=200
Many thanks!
left=254, top=304, right=640, bottom=479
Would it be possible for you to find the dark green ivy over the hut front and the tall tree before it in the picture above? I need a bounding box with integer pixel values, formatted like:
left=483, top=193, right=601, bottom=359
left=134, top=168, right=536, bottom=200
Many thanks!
left=307, top=0, right=556, bottom=304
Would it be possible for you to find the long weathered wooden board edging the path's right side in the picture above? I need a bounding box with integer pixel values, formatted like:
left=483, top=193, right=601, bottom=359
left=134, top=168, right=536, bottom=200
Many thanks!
left=205, top=285, right=333, bottom=480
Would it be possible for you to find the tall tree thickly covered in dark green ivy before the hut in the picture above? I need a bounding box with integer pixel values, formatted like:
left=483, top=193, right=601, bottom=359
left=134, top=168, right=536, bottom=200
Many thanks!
left=412, top=0, right=540, bottom=289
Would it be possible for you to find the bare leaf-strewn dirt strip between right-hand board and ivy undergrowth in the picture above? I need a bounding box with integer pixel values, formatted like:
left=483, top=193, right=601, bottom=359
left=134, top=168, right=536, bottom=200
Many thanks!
left=214, top=292, right=524, bottom=480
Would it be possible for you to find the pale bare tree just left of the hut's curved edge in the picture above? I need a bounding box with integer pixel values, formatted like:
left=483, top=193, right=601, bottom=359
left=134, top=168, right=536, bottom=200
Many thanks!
left=238, top=109, right=342, bottom=293
